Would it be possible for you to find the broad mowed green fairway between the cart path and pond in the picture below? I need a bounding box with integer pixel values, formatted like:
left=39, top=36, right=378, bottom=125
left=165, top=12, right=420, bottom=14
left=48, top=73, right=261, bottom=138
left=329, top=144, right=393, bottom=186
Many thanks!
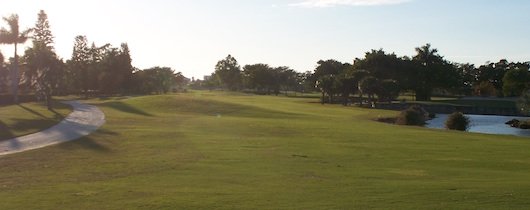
left=0, top=92, right=530, bottom=209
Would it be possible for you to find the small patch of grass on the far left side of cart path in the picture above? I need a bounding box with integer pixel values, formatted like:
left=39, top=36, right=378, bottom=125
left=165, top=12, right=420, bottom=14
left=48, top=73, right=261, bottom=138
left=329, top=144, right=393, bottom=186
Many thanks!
left=0, top=102, right=72, bottom=141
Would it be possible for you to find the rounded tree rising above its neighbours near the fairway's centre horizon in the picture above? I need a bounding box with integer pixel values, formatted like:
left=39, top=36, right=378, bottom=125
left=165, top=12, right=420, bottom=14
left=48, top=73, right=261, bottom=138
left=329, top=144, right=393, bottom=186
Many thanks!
left=215, top=55, right=242, bottom=90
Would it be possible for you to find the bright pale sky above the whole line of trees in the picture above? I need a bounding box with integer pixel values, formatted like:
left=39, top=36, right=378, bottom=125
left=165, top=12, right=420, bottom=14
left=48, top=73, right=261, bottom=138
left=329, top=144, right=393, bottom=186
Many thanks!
left=0, top=0, right=530, bottom=79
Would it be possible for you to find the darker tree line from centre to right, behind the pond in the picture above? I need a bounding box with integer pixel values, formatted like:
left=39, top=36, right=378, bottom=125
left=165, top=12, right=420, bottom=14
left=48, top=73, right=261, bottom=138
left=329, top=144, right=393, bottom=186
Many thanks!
left=194, top=44, right=530, bottom=104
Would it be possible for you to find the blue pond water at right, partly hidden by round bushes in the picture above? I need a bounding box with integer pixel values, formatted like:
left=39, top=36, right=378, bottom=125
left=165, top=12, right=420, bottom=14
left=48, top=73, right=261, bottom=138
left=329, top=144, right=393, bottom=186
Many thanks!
left=425, top=114, right=530, bottom=137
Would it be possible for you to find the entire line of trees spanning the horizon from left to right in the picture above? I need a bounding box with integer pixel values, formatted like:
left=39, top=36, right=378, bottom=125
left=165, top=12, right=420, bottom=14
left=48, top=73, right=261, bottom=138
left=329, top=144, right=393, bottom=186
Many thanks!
left=0, top=11, right=530, bottom=108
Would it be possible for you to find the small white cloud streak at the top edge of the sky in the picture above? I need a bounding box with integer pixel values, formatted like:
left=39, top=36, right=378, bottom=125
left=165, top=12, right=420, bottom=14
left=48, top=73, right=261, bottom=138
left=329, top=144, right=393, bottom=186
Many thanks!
left=289, top=0, right=412, bottom=8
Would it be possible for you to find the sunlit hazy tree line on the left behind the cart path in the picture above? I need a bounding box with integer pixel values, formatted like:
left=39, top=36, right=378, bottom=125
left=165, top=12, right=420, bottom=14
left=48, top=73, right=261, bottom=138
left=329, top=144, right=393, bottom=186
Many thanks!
left=0, top=10, right=188, bottom=109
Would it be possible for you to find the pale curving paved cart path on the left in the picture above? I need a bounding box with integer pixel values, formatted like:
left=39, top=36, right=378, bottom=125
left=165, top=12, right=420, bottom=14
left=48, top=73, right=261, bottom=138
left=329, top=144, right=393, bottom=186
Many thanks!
left=0, top=101, right=105, bottom=156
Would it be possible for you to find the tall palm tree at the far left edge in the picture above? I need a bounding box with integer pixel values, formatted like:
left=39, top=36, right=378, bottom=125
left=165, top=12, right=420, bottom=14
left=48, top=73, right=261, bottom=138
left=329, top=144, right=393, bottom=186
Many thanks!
left=0, top=14, right=31, bottom=104
